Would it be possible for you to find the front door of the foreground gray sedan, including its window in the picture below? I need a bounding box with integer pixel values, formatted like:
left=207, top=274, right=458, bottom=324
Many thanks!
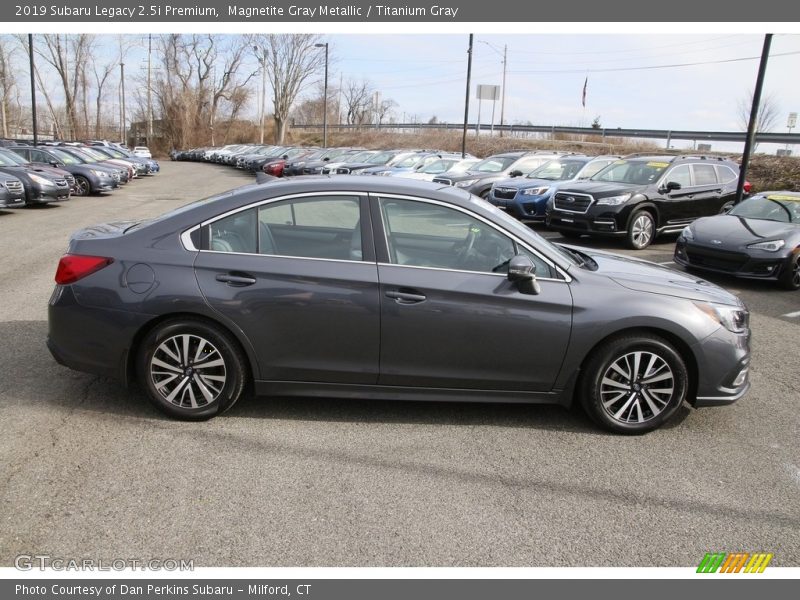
left=371, top=195, right=572, bottom=391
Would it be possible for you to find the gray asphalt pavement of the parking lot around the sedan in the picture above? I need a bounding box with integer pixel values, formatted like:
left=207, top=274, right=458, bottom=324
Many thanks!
left=0, top=162, right=800, bottom=566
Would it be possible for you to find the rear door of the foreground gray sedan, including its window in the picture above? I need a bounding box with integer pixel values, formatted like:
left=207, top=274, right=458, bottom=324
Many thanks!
left=194, top=194, right=380, bottom=384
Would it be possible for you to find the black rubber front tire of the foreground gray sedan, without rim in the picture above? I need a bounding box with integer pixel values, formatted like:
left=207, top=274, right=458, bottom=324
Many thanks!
left=581, top=334, right=689, bottom=435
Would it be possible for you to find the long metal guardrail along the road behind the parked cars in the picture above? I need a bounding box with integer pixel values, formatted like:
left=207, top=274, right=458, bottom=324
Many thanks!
left=292, top=123, right=800, bottom=146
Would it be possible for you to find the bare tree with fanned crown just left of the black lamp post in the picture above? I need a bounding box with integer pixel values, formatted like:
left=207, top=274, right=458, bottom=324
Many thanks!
left=257, top=33, right=325, bottom=144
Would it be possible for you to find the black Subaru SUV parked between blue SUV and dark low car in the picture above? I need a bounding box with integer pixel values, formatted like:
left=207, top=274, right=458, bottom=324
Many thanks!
left=546, top=155, right=749, bottom=250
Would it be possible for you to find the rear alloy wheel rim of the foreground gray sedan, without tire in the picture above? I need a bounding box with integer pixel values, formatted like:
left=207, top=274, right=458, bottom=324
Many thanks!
left=149, top=333, right=227, bottom=409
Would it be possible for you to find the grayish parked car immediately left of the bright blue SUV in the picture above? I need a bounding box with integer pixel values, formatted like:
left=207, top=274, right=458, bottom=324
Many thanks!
left=433, top=150, right=571, bottom=200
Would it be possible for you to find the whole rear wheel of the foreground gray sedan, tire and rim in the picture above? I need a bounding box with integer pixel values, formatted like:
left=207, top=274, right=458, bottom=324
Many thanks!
left=137, top=319, right=248, bottom=421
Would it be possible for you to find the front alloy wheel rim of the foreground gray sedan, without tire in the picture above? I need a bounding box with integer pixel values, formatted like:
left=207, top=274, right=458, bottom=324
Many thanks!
left=600, top=350, right=676, bottom=424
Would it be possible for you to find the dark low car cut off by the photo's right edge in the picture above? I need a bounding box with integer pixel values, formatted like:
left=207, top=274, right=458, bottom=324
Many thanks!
left=674, top=192, right=800, bottom=290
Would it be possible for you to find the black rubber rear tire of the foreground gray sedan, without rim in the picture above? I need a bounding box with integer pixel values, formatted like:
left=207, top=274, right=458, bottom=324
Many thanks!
left=137, top=320, right=246, bottom=421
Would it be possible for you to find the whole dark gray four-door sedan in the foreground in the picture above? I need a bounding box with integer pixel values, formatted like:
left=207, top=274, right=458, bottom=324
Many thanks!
left=48, top=176, right=750, bottom=433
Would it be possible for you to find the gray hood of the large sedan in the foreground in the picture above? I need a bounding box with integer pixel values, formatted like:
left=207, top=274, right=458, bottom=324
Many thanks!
left=562, top=244, right=742, bottom=306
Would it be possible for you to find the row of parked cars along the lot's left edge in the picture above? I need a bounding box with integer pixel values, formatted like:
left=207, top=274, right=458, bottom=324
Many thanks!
left=0, top=142, right=159, bottom=208
